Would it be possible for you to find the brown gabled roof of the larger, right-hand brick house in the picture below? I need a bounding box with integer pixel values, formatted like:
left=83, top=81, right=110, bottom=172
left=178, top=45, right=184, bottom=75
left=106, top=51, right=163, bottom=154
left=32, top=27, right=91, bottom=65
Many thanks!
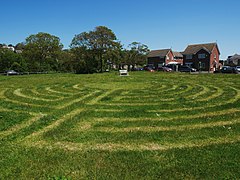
left=183, top=43, right=220, bottom=54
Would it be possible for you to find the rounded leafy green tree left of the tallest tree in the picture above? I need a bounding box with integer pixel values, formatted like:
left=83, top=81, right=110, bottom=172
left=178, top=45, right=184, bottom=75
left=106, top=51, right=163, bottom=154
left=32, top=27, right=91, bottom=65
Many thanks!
left=23, top=32, right=63, bottom=71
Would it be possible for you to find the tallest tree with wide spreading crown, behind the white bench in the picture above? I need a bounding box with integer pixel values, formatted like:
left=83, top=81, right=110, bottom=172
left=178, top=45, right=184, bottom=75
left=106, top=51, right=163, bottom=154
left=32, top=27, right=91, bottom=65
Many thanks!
left=70, top=26, right=119, bottom=72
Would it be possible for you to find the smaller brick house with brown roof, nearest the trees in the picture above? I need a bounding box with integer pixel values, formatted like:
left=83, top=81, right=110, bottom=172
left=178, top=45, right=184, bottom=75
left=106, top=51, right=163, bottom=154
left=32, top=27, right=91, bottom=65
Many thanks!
left=147, top=49, right=183, bottom=68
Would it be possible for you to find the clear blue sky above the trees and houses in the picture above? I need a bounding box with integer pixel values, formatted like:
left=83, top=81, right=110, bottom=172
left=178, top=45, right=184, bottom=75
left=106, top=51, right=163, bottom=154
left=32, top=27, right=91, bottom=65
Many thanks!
left=0, top=0, right=240, bottom=59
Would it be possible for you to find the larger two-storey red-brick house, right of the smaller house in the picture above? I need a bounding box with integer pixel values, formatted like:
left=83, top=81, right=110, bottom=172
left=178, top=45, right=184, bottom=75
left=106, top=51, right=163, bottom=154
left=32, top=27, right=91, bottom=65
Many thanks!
left=182, top=43, right=220, bottom=71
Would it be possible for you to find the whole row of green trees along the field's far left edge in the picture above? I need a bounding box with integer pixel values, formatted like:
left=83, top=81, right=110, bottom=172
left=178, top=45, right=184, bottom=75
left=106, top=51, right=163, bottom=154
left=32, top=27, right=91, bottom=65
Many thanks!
left=0, top=26, right=149, bottom=74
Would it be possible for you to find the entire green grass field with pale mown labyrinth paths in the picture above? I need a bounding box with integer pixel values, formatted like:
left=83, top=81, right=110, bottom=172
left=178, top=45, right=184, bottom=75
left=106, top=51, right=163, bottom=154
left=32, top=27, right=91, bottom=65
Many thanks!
left=0, top=72, right=240, bottom=179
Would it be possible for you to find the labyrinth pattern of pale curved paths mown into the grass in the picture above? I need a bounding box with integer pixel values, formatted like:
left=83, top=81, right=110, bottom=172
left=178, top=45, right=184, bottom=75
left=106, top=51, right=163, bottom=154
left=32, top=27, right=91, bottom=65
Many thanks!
left=0, top=83, right=240, bottom=151
